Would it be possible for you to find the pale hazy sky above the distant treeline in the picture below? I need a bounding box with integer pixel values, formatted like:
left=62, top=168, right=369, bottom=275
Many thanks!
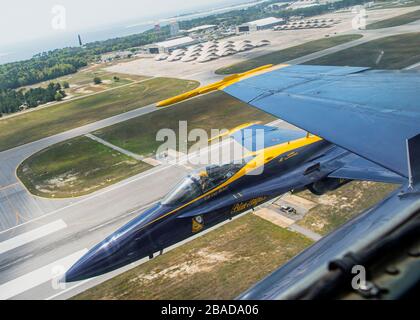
left=0, top=0, right=247, bottom=47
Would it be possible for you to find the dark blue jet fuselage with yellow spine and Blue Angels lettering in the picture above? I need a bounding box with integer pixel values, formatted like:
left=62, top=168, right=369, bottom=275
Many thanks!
left=66, top=133, right=360, bottom=282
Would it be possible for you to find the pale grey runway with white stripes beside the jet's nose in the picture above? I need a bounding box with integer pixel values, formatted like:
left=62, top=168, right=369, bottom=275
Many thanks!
left=0, top=165, right=186, bottom=299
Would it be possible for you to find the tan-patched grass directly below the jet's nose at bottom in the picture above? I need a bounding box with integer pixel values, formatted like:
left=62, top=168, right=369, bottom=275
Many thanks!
left=74, top=214, right=312, bottom=300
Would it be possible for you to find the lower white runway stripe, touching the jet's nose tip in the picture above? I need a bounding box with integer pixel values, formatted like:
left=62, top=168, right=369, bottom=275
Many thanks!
left=0, top=249, right=88, bottom=300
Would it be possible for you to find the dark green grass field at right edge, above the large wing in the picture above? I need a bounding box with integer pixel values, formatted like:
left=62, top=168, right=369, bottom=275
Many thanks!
left=305, top=32, right=420, bottom=69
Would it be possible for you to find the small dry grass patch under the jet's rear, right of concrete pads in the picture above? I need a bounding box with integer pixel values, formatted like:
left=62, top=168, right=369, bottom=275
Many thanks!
left=298, top=181, right=397, bottom=235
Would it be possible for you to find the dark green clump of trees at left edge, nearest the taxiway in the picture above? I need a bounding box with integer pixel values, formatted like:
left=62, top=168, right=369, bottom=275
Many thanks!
left=0, top=83, right=66, bottom=117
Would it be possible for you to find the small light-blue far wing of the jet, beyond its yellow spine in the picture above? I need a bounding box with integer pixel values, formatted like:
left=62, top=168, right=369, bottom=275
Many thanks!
left=230, top=124, right=306, bottom=152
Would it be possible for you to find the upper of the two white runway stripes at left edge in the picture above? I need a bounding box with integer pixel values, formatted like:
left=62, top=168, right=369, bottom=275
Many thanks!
left=0, top=219, right=67, bottom=254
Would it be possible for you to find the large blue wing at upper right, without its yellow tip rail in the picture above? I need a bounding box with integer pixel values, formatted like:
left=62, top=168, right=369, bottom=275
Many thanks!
left=223, top=65, right=420, bottom=178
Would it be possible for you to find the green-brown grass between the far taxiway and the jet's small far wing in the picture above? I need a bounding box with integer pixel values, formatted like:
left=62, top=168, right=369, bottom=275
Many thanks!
left=94, top=91, right=276, bottom=155
